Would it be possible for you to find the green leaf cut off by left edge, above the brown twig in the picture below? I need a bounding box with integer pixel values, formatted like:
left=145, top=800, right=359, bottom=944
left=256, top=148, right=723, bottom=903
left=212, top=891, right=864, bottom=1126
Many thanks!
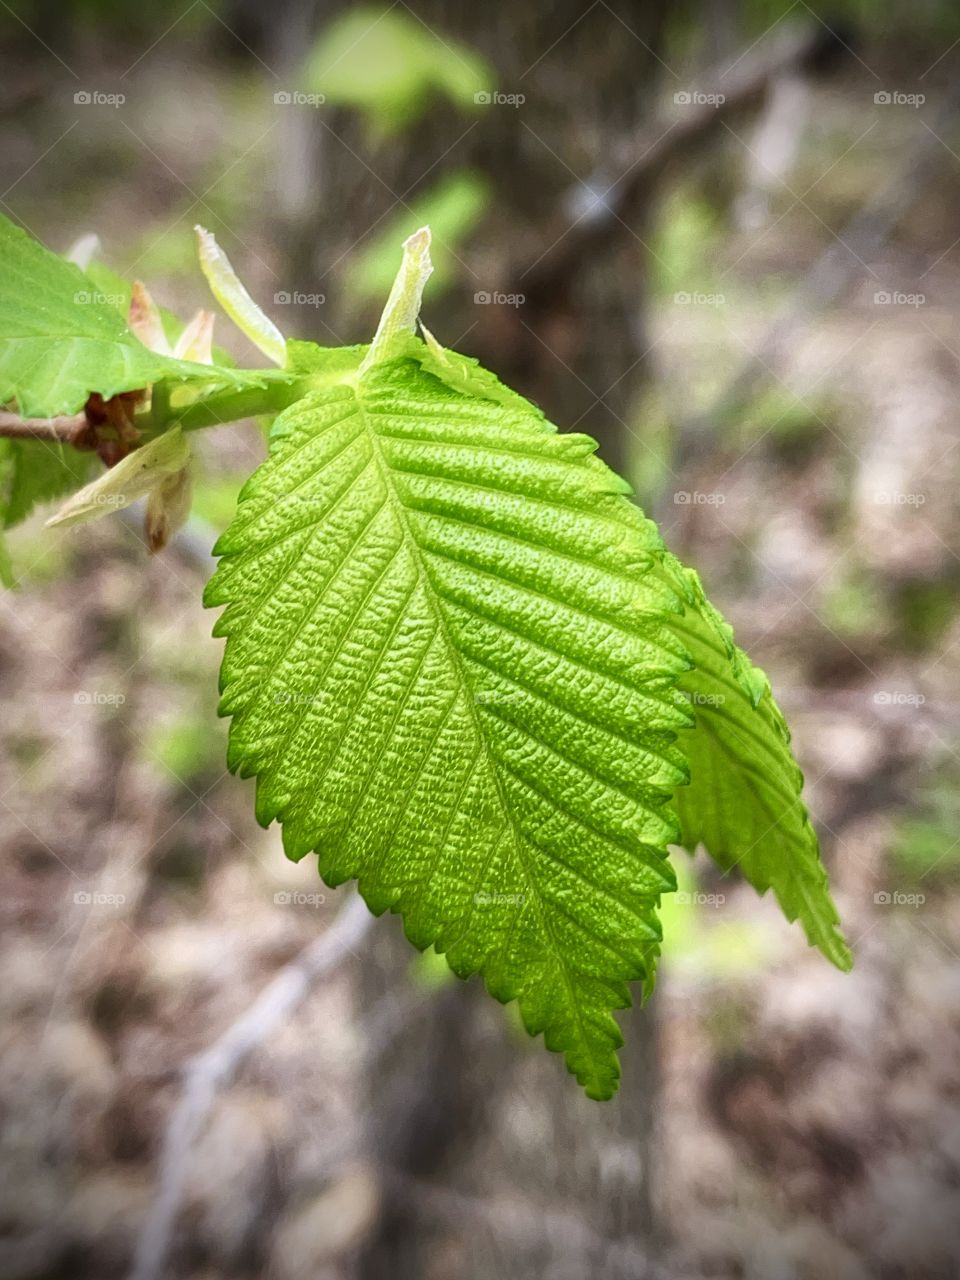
left=0, top=215, right=288, bottom=417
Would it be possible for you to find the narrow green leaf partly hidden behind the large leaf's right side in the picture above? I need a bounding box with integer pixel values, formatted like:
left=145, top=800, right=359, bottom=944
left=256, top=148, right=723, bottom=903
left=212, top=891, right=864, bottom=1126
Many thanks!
left=667, top=557, right=852, bottom=969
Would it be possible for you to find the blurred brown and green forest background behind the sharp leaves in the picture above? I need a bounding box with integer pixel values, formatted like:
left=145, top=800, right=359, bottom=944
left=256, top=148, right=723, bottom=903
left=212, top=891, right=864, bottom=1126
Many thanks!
left=0, top=0, right=960, bottom=1280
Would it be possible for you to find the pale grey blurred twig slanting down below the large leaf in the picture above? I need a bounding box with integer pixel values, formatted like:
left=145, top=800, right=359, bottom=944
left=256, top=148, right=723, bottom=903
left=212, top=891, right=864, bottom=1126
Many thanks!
left=129, top=897, right=372, bottom=1280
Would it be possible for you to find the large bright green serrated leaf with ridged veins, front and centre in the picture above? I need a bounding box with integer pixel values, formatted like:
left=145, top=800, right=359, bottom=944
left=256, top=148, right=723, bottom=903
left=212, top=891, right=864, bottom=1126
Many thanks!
left=206, top=348, right=690, bottom=1098
